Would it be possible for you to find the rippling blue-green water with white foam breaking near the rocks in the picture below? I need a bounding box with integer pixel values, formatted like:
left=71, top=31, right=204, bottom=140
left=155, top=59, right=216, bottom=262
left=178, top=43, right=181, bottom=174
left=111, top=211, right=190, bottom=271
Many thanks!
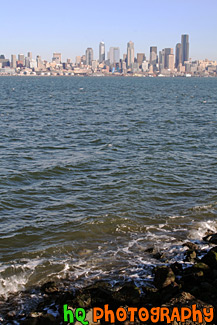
left=0, top=77, right=217, bottom=295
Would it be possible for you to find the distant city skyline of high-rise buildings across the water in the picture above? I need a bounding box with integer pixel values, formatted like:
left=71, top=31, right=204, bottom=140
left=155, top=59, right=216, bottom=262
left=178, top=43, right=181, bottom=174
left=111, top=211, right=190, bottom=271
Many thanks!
left=0, top=34, right=217, bottom=77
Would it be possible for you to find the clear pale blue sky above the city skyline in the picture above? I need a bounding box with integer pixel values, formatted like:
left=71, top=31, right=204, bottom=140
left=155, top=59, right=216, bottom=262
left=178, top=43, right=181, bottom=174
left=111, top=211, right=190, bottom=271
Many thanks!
left=0, top=0, right=217, bottom=62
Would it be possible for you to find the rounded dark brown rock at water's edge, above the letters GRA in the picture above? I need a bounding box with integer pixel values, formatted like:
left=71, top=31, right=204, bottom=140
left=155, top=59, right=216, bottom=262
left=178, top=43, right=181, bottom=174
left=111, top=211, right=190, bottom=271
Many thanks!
left=154, top=266, right=176, bottom=289
